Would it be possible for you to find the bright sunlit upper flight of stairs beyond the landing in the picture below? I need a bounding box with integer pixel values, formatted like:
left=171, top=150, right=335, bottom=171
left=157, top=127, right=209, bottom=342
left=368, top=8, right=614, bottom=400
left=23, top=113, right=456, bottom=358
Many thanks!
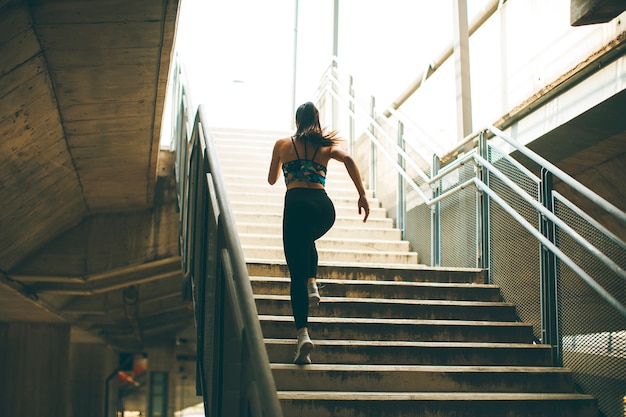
left=211, top=129, right=418, bottom=266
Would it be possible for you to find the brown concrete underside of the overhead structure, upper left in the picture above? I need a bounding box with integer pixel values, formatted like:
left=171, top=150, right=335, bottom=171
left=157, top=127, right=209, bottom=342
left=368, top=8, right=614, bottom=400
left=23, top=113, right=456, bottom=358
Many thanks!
left=0, top=0, right=193, bottom=350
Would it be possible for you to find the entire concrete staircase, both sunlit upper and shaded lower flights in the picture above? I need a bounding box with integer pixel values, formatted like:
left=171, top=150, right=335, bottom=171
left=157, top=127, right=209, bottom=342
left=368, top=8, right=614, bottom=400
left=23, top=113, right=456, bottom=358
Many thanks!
left=212, top=130, right=598, bottom=417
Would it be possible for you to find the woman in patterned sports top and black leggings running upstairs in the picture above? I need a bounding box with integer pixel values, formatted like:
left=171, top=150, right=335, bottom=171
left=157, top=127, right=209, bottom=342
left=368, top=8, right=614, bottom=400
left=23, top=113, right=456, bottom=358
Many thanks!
left=267, top=102, right=370, bottom=364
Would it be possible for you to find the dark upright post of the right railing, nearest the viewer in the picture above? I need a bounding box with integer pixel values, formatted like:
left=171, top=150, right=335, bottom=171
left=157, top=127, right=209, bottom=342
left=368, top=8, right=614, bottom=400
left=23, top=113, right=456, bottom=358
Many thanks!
left=540, top=168, right=562, bottom=366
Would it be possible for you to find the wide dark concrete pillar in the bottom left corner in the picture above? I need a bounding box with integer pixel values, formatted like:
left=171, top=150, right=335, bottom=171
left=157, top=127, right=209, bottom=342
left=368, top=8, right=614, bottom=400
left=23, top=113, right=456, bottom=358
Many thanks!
left=0, top=323, right=70, bottom=417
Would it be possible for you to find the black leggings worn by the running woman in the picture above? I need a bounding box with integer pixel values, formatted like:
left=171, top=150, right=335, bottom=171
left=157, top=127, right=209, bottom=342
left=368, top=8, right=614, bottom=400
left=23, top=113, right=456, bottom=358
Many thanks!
left=283, top=188, right=335, bottom=329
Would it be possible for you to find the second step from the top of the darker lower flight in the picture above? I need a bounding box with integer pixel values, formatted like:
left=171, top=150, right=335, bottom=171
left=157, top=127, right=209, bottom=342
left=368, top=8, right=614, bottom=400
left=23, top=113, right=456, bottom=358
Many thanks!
left=250, top=276, right=500, bottom=302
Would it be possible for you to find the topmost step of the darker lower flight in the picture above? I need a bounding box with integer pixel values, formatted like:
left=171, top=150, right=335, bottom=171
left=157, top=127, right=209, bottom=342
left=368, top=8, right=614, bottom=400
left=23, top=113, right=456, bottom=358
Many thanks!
left=247, top=262, right=486, bottom=284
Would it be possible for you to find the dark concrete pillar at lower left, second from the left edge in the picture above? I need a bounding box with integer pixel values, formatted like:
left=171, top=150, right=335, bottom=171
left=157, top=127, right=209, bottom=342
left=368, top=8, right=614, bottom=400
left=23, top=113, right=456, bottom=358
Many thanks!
left=69, top=343, right=118, bottom=417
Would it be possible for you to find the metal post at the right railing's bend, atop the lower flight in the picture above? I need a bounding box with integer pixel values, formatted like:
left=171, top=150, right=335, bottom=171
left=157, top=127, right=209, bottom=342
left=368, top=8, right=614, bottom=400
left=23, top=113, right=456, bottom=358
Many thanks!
left=476, top=130, right=491, bottom=283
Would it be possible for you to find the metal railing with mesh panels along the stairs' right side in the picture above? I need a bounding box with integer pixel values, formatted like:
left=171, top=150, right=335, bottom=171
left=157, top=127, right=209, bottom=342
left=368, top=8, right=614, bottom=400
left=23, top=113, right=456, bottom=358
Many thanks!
left=317, top=57, right=626, bottom=415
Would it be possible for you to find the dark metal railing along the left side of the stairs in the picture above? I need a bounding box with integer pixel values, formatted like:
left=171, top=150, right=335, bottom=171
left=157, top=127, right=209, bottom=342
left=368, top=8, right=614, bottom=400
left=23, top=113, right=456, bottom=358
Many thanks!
left=166, top=61, right=282, bottom=417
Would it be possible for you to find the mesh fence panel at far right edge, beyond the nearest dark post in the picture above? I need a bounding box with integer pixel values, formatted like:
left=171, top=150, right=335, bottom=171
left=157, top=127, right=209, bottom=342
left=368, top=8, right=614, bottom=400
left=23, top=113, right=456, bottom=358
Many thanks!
left=554, top=194, right=626, bottom=417
